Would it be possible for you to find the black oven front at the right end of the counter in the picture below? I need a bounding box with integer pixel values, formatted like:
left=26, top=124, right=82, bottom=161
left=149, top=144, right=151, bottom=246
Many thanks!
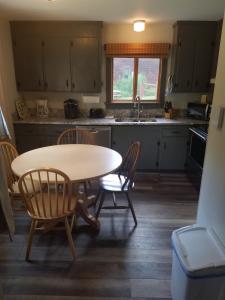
left=187, top=127, right=208, bottom=191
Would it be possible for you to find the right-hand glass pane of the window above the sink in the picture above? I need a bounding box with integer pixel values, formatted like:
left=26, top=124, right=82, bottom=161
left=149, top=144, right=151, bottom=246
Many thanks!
left=137, top=58, right=160, bottom=100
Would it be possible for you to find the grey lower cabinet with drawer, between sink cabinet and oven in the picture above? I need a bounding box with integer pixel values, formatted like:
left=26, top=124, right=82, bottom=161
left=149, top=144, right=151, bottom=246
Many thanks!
left=159, top=126, right=189, bottom=170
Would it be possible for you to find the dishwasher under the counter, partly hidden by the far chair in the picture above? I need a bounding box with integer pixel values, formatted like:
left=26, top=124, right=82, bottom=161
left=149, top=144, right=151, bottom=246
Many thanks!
left=76, top=126, right=111, bottom=148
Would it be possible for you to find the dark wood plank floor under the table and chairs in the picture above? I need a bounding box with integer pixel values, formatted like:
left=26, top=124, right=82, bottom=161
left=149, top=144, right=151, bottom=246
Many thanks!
left=0, top=174, right=197, bottom=300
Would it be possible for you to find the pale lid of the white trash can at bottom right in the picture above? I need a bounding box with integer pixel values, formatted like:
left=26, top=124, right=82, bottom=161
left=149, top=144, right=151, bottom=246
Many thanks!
left=172, top=225, right=225, bottom=278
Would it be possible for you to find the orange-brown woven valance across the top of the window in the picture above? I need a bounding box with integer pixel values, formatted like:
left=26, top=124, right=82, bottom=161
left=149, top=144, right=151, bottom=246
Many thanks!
left=105, top=43, right=170, bottom=57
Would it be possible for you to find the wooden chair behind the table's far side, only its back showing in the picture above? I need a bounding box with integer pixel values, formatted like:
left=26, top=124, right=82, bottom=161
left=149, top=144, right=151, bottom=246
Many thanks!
left=57, top=128, right=97, bottom=145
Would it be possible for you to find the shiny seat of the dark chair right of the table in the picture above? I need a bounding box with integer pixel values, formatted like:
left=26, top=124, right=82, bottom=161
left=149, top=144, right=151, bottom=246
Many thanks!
left=100, top=174, right=134, bottom=192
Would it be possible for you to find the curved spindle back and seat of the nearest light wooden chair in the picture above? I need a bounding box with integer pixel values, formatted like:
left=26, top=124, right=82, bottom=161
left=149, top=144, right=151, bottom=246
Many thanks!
left=19, top=169, right=75, bottom=220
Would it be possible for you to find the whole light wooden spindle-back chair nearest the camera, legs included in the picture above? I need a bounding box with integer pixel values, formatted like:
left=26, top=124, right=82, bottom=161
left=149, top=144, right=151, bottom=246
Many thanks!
left=19, top=168, right=77, bottom=260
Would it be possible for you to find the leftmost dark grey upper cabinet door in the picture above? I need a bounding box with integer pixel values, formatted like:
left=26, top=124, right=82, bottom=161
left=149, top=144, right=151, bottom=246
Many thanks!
left=13, top=37, right=44, bottom=91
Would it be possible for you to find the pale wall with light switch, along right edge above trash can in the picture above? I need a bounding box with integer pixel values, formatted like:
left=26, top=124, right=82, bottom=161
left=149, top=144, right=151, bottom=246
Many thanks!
left=197, top=13, right=225, bottom=242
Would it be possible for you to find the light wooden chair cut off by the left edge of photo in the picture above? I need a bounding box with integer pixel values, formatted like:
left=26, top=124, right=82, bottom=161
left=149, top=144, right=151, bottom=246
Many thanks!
left=0, top=141, right=22, bottom=209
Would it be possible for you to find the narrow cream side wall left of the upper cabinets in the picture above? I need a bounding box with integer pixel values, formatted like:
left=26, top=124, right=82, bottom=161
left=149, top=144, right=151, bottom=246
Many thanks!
left=0, top=20, right=18, bottom=134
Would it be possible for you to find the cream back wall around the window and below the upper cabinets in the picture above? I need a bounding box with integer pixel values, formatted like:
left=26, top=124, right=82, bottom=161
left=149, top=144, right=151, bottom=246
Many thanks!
left=21, top=22, right=200, bottom=115
